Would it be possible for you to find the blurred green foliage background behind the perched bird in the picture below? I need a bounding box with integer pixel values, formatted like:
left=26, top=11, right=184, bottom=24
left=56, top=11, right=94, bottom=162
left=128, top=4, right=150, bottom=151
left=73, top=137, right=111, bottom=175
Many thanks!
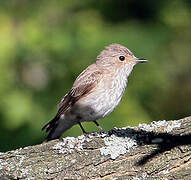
left=0, top=0, right=191, bottom=151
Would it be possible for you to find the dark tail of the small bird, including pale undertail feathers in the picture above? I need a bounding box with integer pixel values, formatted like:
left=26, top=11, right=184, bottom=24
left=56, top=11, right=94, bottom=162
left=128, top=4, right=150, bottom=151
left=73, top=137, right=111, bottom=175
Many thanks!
left=42, top=116, right=74, bottom=141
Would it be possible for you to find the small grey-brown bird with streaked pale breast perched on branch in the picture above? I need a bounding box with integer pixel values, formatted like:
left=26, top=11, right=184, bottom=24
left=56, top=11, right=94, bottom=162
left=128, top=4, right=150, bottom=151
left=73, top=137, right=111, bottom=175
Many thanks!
left=42, top=44, right=148, bottom=141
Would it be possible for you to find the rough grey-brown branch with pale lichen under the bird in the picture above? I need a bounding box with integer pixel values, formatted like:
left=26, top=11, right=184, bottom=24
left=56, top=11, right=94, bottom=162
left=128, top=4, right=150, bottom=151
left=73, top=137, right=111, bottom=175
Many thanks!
left=0, top=117, right=191, bottom=180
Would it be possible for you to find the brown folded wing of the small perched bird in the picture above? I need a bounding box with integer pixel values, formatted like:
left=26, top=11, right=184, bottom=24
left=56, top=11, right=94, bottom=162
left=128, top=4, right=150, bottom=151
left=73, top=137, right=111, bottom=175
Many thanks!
left=56, top=64, right=102, bottom=117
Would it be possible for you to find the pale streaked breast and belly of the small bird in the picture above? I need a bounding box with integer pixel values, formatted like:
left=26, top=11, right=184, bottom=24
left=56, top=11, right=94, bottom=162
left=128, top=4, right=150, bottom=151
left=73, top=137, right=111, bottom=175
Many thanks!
left=77, top=69, right=127, bottom=120
